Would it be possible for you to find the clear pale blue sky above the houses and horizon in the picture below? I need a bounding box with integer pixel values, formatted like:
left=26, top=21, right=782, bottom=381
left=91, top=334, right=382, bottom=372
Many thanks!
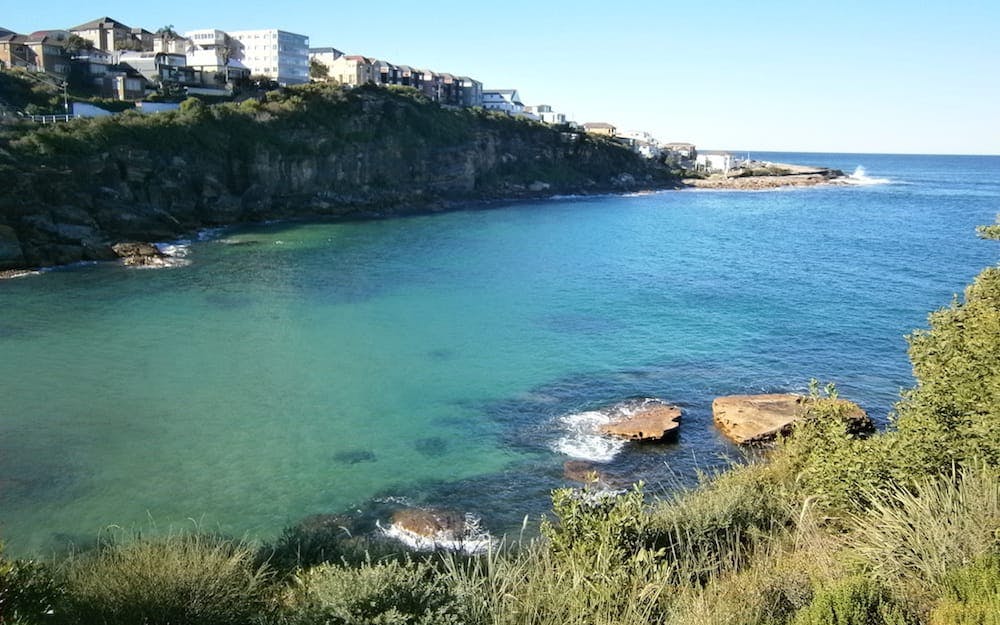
left=0, top=0, right=1000, bottom=154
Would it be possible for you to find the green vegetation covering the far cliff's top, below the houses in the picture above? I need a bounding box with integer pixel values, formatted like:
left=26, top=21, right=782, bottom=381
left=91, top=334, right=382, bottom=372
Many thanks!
left=0, top=74, right=666, bottom=186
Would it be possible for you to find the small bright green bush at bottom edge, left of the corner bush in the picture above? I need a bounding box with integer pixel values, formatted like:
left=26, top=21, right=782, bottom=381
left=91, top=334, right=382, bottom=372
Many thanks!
left=792, top=577, right=917, bottom=625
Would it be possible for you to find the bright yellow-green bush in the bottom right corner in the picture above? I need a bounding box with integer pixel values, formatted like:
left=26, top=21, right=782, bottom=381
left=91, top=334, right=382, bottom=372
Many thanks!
left=930, top=554, right=1000, bottom=625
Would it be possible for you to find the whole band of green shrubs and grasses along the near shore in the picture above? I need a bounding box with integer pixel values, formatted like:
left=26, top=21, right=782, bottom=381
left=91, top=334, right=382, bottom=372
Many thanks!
left=0, top=217, right=1000, bottom=625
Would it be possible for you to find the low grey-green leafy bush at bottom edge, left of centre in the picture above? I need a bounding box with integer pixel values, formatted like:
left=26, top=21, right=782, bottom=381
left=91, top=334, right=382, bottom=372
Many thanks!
left=285, top=561, right=461, bottom=625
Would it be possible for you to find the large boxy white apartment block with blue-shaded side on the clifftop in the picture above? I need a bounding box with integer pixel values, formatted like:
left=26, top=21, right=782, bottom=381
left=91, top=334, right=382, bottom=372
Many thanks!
left=228, top=28, right=309, bottom=85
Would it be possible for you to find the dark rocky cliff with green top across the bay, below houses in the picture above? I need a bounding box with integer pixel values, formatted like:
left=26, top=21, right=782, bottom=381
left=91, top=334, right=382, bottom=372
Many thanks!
left=0, top=85, right=676, bottom=270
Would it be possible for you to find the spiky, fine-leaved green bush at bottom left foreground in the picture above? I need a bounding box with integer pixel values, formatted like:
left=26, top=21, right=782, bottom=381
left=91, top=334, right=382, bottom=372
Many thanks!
left=64, top=534, right=271, bottom=625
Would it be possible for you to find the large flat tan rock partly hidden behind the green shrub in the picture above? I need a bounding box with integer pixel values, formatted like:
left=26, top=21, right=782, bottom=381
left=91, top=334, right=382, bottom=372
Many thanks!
left=712, top=394, right=872, bottom=445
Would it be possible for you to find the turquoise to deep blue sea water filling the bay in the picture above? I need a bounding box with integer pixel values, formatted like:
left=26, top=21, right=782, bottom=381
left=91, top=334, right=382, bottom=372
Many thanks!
left=0, top=155, right=1000, bottom=553
